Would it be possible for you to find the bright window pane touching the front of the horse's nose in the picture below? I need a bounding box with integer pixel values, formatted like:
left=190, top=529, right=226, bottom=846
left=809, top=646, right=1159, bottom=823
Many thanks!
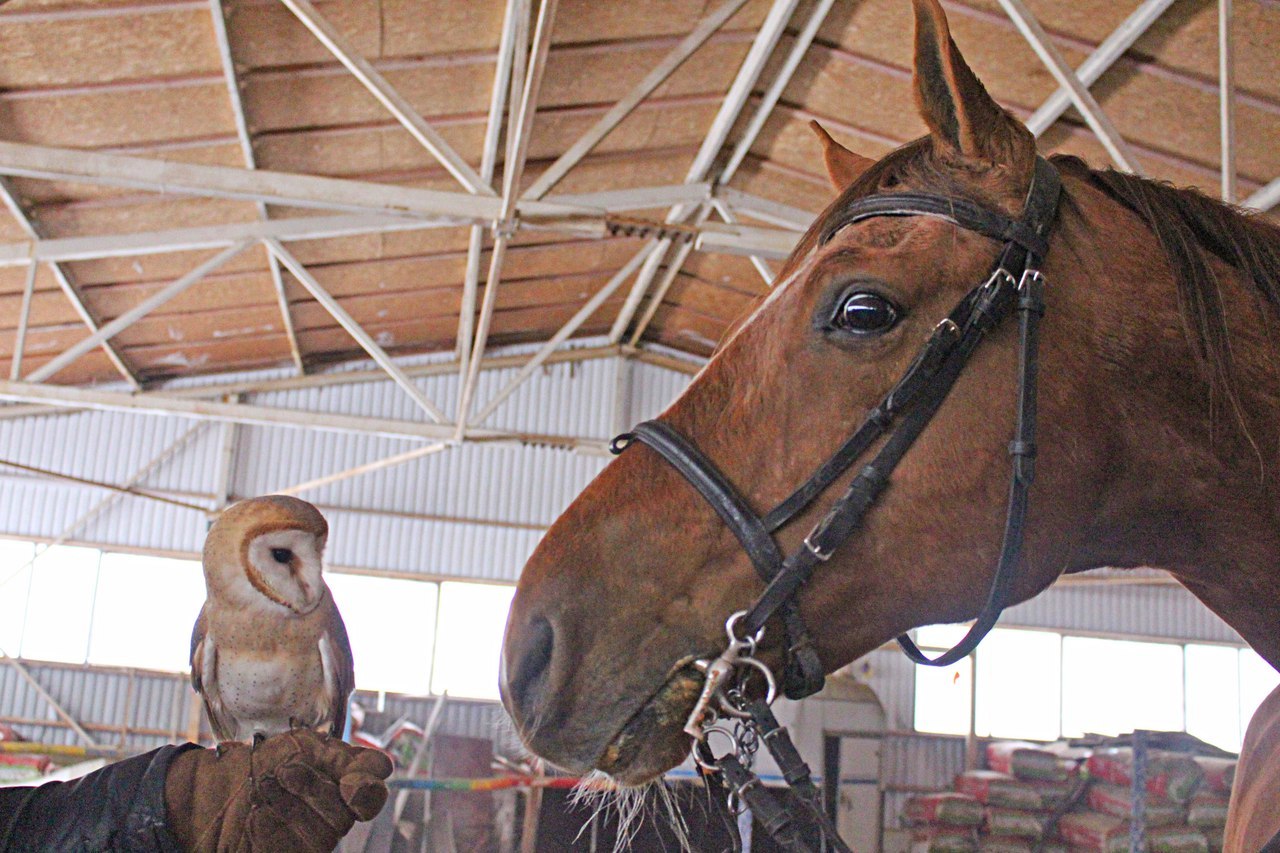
left=431, top=583, right=516, bottom=699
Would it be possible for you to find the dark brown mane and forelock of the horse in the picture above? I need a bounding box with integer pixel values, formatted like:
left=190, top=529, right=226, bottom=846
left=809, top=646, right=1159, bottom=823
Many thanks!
left=777, top=137, right=1280, bottom=443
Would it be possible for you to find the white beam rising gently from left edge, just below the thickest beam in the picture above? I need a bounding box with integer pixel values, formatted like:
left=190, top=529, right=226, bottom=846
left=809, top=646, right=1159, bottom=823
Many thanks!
left=0, top=214, right=448, bottom=266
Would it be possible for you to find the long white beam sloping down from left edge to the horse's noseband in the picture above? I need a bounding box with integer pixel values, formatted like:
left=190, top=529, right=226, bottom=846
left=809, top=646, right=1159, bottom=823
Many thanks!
left=0, top=377, right=605, bottom=452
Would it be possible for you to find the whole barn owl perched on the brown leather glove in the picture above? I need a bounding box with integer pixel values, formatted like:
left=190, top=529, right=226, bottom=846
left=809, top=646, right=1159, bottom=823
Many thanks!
left=191, top=494, right=356, bottom=742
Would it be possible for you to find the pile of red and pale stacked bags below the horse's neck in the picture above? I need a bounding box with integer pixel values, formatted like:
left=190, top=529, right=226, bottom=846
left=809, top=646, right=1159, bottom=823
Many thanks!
left=902, top=742, right=1235, bottom=853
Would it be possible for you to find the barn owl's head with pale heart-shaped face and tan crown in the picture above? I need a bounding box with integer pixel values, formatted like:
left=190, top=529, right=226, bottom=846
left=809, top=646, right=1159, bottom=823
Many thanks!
left=205, top=494, right=329, bottom=615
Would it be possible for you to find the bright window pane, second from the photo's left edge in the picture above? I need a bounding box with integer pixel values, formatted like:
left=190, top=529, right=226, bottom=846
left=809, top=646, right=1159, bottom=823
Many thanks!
left=18, top=546, right=101, bottom=663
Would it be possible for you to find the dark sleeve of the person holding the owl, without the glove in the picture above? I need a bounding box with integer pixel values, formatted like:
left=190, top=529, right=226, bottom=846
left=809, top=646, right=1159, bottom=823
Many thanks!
left=0, top=743, right=198, bottom=853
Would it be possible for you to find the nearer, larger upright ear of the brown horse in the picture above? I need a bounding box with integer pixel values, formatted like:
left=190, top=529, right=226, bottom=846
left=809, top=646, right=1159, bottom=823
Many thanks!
left=911, top=0, right=1036, bottom=165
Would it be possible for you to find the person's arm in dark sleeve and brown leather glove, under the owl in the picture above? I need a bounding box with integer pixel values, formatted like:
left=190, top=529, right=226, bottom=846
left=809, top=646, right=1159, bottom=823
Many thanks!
left=0, top=729, right=392, bottom=853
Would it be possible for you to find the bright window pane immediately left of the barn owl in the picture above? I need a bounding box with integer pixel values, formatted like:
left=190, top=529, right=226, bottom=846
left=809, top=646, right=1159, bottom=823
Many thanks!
left=88, top=553, right=205, bottom=672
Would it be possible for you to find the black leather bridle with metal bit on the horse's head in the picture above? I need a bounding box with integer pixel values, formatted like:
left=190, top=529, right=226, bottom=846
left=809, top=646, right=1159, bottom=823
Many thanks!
left=612, top=158, right=1061, bottom=850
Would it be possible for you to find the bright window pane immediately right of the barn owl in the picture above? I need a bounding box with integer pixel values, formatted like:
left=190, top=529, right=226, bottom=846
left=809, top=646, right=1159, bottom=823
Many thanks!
left=325, top=573, right=438, bottom=695
